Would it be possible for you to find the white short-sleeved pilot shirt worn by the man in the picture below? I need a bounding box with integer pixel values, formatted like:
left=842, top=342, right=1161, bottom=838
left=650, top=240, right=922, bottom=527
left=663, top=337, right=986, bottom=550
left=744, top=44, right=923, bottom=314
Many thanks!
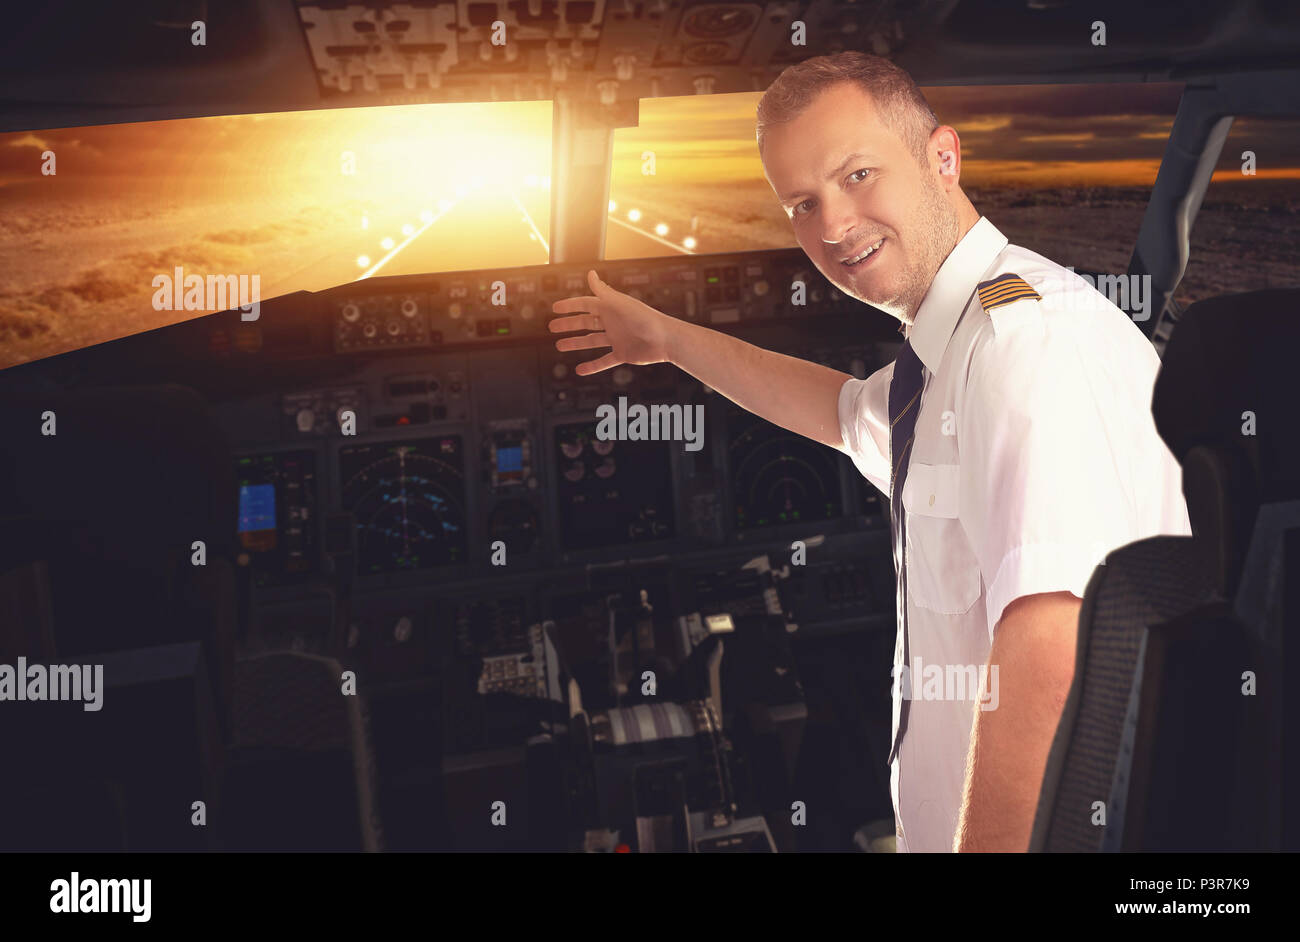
left=839, top=217, right=1191, bottom=852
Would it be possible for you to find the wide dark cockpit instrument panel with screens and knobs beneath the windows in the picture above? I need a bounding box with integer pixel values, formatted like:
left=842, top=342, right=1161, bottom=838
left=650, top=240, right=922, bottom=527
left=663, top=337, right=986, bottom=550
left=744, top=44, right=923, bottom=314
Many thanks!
left=202, top=249, right=897, bottom=594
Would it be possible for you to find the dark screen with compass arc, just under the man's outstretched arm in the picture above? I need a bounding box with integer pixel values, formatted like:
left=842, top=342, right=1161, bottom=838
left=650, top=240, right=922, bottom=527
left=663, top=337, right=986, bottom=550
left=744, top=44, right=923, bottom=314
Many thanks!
left=727, top=411, right=842, bottom=531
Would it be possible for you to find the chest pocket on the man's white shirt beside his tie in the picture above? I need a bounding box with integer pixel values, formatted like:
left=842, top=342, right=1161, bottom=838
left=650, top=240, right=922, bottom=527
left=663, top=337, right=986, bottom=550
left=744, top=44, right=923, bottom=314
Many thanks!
left=902, top=461, right=980, bottom=615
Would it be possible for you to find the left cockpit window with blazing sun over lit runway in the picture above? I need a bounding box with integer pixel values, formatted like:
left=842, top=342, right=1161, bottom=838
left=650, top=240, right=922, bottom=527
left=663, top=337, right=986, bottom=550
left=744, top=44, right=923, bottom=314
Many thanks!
left=0, top=101, right=551, bottom=368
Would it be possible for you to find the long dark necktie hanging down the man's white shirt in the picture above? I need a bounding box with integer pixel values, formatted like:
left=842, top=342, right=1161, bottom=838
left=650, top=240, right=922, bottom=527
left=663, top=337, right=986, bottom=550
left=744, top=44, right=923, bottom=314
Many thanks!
left=889, top=340, right=926, bottom=764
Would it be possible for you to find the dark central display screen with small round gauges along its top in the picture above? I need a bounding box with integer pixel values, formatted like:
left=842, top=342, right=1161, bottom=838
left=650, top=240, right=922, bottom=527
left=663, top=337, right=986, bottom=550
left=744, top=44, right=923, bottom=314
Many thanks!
left=555, top=420, right=675, bottom=550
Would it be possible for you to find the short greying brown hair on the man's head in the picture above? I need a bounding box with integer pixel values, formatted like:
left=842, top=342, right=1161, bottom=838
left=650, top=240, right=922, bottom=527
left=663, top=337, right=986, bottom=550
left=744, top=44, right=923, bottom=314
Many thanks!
left=754, top=51, right=939, bottom=162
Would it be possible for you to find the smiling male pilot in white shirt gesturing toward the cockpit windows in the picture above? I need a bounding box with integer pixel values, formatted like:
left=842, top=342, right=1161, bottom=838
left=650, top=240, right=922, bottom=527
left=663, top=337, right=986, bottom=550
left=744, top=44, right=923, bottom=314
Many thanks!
left=551, top=52, right=1191, bottom=851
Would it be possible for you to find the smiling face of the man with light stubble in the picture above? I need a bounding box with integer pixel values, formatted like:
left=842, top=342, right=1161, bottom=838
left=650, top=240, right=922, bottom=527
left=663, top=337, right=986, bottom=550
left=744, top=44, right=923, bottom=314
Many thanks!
left=763, top=82, right=959, bottom=322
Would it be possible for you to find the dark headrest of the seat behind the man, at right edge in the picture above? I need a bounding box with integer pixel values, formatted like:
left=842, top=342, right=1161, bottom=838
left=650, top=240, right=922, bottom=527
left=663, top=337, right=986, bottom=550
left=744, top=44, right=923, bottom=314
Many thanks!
left=1152, top=288, right=1300, bottom=503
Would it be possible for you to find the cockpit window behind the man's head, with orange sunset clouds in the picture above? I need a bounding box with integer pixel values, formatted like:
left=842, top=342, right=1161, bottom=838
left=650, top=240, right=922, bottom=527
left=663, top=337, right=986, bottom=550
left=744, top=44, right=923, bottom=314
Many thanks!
left=605, top=83, right=1183, bottom=280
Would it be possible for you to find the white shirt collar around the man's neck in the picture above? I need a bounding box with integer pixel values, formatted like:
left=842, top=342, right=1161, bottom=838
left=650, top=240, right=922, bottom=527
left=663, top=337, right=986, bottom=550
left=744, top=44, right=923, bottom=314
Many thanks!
left=904, top=216, right=1008, bottom=373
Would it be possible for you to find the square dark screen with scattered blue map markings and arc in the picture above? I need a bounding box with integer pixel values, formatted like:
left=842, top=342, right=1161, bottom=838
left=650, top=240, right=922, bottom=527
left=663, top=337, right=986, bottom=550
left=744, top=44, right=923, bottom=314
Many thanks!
left=338, top=435, right=467, bottom=574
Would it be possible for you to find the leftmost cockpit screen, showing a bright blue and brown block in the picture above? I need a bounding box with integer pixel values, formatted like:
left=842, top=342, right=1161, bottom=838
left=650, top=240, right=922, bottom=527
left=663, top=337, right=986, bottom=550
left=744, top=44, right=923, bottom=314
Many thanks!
left=235, top=451, right=316, bottom=586
